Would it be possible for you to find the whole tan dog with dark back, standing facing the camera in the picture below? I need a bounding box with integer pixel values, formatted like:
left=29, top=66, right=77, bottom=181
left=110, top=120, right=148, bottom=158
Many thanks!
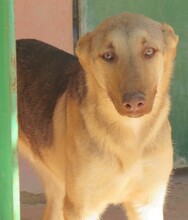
left=17, top=13, right=178, bottom=220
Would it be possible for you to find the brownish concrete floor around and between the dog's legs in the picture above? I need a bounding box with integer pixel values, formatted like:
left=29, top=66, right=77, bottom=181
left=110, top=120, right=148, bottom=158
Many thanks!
left=21, top=169, right=188, bottom=220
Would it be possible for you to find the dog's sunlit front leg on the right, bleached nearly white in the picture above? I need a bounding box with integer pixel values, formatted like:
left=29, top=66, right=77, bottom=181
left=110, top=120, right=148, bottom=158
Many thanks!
left=125, top=185, right=166, bottom=220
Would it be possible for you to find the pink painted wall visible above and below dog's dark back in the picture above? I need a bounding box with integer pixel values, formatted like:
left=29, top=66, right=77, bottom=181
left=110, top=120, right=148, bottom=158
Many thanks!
left=15, top=0, right=73, bottom=193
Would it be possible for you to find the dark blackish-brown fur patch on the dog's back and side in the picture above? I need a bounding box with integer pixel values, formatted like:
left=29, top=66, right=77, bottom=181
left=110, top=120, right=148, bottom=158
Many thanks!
left=16, top=39, right=84, bottom=150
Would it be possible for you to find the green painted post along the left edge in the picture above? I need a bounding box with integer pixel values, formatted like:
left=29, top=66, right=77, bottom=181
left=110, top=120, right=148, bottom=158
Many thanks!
left=0, top=0, right=20, bottom=220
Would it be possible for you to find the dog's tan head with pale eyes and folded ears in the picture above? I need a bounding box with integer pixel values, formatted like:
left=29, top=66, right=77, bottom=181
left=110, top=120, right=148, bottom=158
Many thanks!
left=76, top=13, right=178, bottom=117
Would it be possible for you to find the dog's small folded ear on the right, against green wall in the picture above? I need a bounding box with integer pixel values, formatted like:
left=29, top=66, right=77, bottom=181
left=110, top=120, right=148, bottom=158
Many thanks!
left=161, top=23, right=179, bottom=49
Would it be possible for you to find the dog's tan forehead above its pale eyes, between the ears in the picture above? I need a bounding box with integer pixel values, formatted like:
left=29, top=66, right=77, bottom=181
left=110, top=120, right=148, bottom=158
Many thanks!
left=93, top=13, right=163, bottom=47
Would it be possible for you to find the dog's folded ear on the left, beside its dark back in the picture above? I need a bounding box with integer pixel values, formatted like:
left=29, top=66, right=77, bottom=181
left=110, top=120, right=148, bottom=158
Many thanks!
left=75, top=33, right=91, bottom=64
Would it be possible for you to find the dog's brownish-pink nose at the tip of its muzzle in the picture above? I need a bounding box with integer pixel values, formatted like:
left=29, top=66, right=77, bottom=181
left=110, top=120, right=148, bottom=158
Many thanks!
left=123, top=92, right=145, bottom=112
